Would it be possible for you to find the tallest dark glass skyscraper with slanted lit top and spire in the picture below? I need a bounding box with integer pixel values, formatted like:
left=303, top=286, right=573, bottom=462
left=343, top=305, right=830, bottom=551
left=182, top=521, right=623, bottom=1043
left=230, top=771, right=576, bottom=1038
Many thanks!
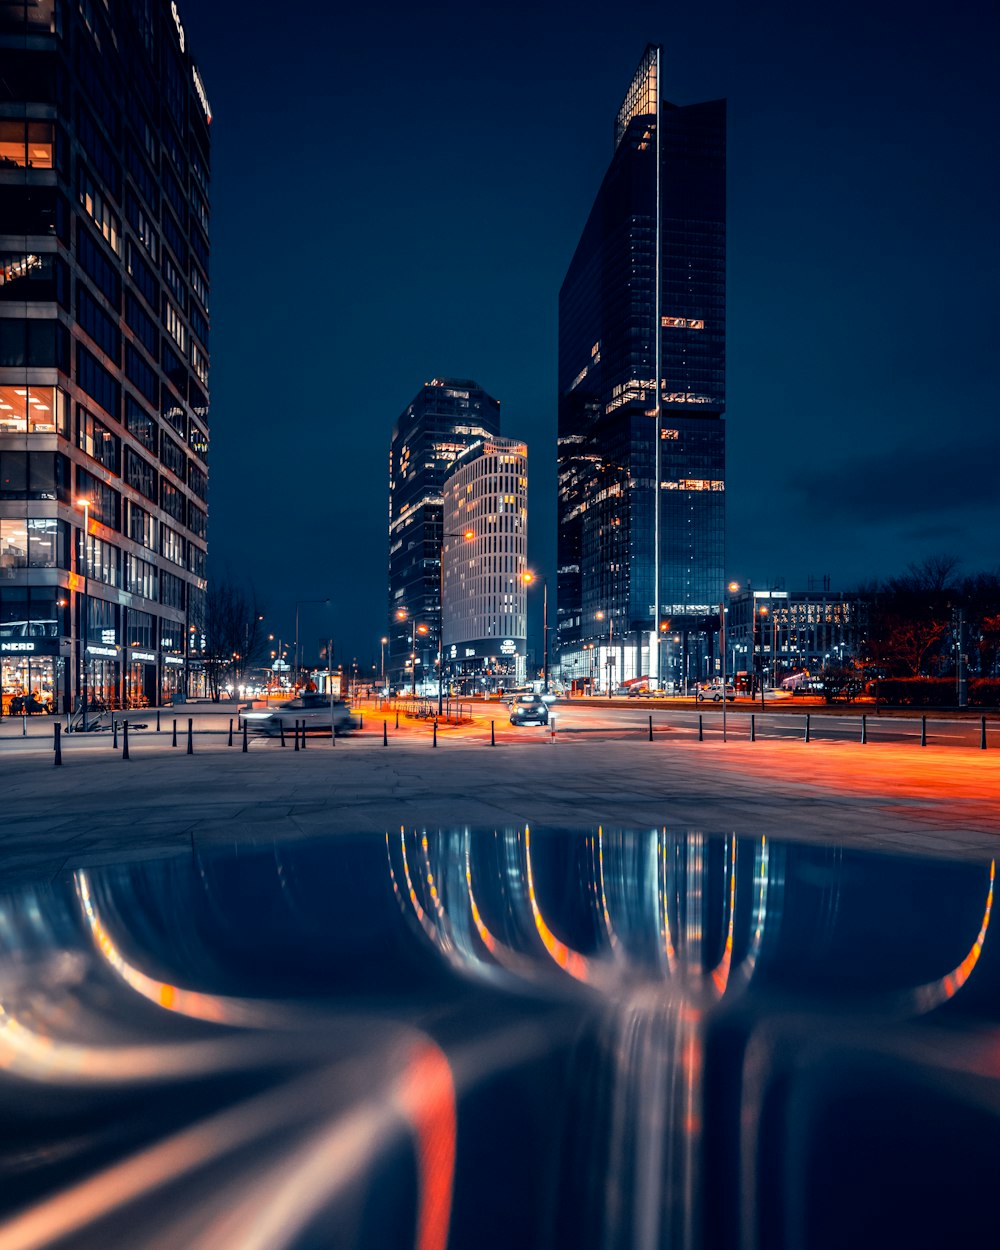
left=559, top=46, right=725, bottom=685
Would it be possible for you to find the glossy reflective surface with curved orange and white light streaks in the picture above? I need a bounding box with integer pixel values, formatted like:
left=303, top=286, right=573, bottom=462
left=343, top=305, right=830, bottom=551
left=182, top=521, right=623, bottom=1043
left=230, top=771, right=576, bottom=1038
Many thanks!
left=0, top=828, right=1000, bottom=1250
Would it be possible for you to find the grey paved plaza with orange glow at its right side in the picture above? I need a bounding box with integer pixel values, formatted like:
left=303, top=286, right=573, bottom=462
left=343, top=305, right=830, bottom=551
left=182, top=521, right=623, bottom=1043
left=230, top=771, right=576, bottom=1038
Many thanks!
left=0, top=709, right=1000, bottom=880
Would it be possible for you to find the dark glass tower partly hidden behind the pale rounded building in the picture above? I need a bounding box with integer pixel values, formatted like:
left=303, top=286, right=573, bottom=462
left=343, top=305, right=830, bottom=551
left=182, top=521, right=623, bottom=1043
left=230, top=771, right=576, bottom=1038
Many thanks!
left=386, top=378, right=500, bottom=689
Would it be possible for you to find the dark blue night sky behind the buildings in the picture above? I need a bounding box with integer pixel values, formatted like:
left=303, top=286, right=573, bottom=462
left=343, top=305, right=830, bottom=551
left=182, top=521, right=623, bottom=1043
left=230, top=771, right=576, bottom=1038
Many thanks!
left=180, top=0, right=1000, bottom=670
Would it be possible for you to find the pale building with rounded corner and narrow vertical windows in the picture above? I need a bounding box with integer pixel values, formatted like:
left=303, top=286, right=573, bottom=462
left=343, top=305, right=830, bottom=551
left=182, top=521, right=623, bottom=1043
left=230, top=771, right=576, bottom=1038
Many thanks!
left=441, top=439, right=528, bottom=694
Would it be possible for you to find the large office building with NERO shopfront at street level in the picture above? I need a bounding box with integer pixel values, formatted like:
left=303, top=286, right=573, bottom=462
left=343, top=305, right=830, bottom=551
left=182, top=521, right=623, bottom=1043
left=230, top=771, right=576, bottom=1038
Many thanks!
left=0, top=0, right=210, bottom=710
